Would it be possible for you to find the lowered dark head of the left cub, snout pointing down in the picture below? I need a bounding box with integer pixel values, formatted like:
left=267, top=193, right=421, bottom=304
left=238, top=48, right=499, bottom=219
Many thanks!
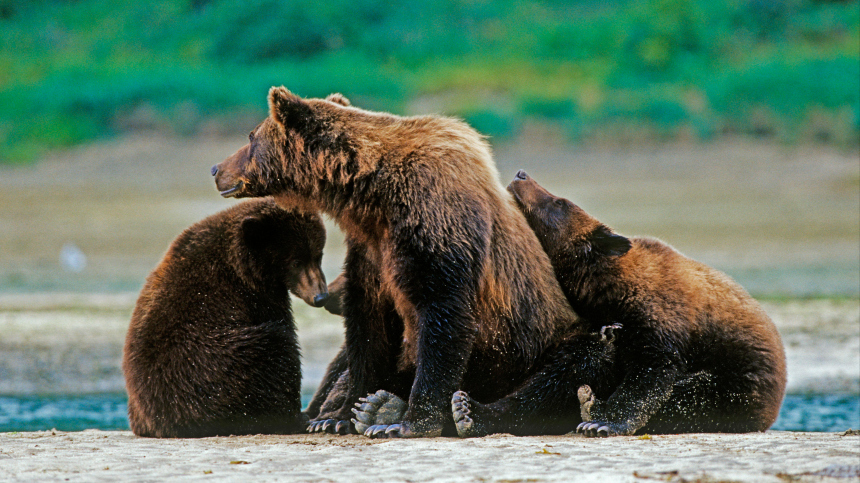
left=231, top=200, right=328, bottom=307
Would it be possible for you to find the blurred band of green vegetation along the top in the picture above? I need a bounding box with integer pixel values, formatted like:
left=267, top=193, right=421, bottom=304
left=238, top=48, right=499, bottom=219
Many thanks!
left=0, top=0, right=860, bottom=162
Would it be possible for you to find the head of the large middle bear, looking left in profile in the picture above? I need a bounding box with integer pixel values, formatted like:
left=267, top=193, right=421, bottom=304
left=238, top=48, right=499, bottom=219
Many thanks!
left=211, top=87, right=351, bottom=203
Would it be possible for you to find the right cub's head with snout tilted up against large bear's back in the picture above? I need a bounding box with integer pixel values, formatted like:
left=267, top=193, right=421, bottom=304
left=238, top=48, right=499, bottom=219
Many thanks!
left=508, top=170, right=630, bottom=260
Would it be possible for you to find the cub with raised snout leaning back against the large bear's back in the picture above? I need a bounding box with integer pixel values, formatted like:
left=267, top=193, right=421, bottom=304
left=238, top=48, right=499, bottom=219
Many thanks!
left=484, top=171, right=786, bottom=436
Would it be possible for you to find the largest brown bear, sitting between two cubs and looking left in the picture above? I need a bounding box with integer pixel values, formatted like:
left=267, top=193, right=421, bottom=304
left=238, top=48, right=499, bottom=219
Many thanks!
left=213, top=87, right=579, bottom=436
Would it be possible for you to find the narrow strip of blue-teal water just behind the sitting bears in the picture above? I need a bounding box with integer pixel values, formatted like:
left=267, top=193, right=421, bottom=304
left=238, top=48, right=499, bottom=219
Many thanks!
left=0, top=393, right=860, bottom=432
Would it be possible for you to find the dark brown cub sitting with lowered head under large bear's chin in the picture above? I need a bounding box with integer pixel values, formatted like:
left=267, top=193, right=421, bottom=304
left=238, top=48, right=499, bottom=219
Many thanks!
left=123, top=199, right=327, bottom=438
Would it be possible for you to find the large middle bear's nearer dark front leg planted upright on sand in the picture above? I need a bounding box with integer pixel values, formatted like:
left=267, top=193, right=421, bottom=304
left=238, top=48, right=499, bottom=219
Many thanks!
left=372, top=227, right=490, bottom=437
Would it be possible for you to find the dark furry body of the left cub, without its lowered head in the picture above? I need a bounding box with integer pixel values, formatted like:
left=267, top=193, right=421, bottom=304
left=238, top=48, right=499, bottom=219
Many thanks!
left=122, top=200, right=301, bottom=437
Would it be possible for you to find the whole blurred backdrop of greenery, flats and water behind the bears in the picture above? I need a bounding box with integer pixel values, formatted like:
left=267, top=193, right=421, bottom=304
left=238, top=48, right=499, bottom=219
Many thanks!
left=0, top=0, right=860, bottom=431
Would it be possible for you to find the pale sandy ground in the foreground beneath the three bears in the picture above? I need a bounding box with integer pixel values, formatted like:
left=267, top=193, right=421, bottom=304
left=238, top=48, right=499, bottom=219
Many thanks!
left=0, top=430, right=860, bottom=482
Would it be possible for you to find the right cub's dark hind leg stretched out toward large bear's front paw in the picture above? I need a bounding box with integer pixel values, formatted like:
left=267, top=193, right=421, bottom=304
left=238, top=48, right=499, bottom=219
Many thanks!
left=451, top=335, right=616, bottom=437
